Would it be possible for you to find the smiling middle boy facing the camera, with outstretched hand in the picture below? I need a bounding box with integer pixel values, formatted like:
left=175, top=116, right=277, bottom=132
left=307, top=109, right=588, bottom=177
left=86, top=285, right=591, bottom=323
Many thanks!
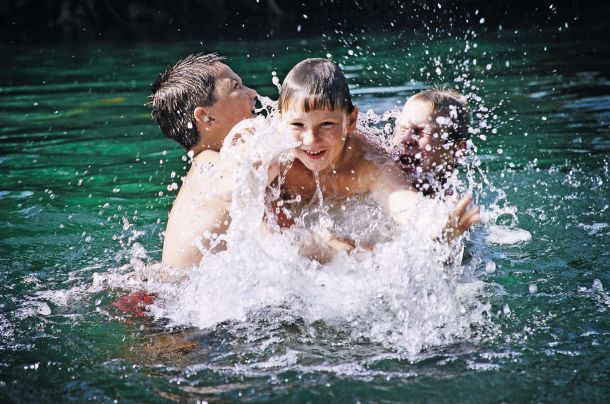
left=279, top=59, right=479, bottom=245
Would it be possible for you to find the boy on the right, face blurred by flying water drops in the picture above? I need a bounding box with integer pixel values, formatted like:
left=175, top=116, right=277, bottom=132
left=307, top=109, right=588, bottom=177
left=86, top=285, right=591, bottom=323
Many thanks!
left=392, top=89, right=470, bottom=196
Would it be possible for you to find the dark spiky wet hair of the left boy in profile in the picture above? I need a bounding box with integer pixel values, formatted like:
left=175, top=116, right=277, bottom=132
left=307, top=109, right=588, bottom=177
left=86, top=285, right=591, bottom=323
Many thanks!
left=149, top=53, right=223, bottom=150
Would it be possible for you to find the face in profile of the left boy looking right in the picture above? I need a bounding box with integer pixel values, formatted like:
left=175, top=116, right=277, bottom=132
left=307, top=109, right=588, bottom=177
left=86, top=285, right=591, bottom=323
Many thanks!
left=205, top=64, right=257, bottom=136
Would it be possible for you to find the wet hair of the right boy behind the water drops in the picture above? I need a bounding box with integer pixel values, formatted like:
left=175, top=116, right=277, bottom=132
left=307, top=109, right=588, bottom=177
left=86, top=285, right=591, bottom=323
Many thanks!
left=407, top=89, right=471, bottom=140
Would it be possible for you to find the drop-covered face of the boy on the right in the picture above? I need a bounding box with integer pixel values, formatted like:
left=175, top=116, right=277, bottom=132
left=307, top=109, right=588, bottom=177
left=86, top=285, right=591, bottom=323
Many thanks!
left=392, top=101, right=466, bottom=177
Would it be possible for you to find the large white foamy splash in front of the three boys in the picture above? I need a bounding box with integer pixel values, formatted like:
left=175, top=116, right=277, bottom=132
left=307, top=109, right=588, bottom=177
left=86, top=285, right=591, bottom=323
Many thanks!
left=134, top=103, right=487, bottom=353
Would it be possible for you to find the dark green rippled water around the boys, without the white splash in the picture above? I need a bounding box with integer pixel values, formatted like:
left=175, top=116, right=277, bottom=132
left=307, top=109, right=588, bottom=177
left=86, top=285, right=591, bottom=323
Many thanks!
left=0, top=1, right=610, bottom=402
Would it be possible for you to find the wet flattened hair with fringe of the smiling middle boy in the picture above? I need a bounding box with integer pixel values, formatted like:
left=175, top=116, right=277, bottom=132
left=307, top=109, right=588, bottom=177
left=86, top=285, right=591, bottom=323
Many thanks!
left=279, top=58, right=354, bottom=114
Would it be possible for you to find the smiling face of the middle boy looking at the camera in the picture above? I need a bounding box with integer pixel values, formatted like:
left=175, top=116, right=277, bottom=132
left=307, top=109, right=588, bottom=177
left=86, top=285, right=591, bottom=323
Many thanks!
left=282, top=108, right=358, bottom=172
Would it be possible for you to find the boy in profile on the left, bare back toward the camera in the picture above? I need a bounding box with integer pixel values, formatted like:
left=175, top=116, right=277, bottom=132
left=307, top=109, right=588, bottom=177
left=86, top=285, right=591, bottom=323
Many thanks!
left=150, top=54, right=257, bottom=268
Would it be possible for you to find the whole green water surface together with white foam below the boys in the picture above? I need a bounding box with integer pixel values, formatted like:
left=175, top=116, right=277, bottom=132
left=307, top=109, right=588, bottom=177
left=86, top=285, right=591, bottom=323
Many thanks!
left=0, top=21, right=610, bottom=402
